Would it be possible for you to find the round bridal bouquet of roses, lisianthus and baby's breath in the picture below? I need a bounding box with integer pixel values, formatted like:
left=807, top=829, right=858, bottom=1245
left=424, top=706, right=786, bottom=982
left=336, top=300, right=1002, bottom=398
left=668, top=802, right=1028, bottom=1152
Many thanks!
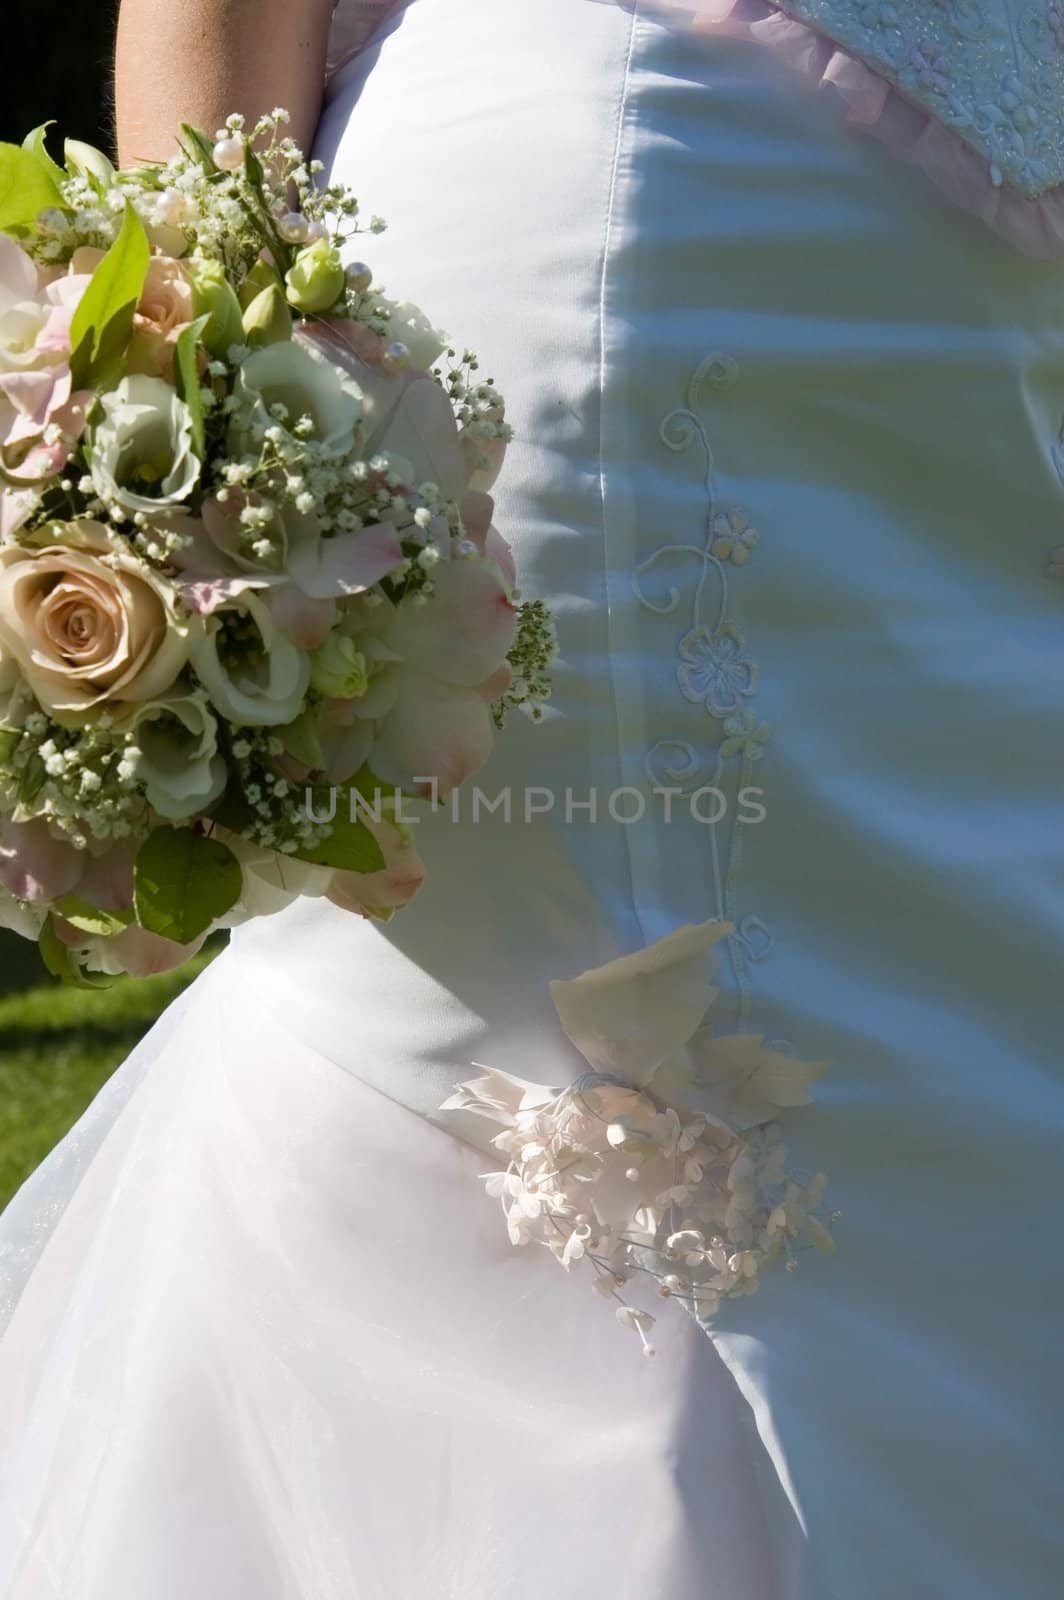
left=0, top=112, right=552, bottom=982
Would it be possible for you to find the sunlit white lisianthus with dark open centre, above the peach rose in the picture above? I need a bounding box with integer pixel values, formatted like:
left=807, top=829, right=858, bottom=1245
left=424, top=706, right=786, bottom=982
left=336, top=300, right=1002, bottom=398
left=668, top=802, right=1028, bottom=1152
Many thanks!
left=88, top=374, right=200, bottom=517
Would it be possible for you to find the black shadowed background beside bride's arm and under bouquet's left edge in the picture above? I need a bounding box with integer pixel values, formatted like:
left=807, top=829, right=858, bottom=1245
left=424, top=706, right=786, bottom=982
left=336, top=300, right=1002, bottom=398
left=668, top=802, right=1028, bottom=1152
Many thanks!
left=0, top=0, right=118, bottom=992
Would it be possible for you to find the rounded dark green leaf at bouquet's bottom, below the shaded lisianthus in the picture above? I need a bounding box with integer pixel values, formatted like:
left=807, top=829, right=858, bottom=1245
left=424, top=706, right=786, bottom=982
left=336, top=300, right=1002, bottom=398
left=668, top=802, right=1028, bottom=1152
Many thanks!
left=133, top=827, right=243, bottom=944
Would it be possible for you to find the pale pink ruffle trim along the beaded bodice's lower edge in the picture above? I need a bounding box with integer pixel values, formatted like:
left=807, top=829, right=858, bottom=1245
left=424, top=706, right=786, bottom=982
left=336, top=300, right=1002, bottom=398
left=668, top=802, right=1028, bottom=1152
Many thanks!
left=627, top=0, right=1064, bottom=258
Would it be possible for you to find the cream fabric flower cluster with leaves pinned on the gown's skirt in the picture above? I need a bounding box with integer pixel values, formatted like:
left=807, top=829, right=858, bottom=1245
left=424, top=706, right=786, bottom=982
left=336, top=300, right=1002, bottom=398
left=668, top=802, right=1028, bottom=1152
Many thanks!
left=442, top=922, right=840, bottom=1355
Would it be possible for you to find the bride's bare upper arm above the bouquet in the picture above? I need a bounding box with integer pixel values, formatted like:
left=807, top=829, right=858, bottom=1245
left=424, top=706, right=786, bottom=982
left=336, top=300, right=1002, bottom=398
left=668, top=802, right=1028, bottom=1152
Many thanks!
left=115, top=0, right=333, bottom=165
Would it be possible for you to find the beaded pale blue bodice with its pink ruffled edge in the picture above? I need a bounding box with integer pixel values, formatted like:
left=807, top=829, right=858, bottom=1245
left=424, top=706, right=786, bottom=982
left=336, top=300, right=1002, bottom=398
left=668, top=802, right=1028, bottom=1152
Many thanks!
left=330, top=0, right=1064, bottom=256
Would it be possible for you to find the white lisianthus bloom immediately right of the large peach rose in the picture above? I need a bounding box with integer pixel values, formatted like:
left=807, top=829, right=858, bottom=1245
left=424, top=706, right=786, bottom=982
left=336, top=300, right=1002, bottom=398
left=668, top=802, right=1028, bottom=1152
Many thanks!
left=190, top=590, right=310, bottom=728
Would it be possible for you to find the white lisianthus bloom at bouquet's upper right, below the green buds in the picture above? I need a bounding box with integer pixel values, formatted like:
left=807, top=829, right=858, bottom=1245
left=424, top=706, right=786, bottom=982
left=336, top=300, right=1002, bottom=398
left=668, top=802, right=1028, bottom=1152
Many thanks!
left=234, top=339, right=362, bottom=456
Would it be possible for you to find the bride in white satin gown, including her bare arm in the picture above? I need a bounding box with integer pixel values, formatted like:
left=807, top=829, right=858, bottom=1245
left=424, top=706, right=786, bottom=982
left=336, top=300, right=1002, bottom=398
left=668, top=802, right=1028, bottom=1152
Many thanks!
left=0, top=0, right=1064, bottom=1600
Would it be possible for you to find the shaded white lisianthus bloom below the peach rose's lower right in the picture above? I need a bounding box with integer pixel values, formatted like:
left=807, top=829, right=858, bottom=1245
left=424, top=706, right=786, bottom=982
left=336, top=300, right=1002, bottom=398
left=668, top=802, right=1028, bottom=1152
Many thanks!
left=122, top=690, right=226, bottom=822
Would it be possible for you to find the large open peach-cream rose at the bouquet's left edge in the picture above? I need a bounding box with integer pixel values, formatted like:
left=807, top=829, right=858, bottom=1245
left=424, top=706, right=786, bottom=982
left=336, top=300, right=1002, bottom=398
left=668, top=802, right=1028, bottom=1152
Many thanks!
left=0, top=522, right=202, bottom=722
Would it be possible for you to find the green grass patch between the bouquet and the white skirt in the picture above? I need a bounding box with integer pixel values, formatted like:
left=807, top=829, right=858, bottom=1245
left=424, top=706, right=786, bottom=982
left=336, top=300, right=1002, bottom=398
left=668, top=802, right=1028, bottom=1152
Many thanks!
left=0, top=952, right=213, bottom=1208
